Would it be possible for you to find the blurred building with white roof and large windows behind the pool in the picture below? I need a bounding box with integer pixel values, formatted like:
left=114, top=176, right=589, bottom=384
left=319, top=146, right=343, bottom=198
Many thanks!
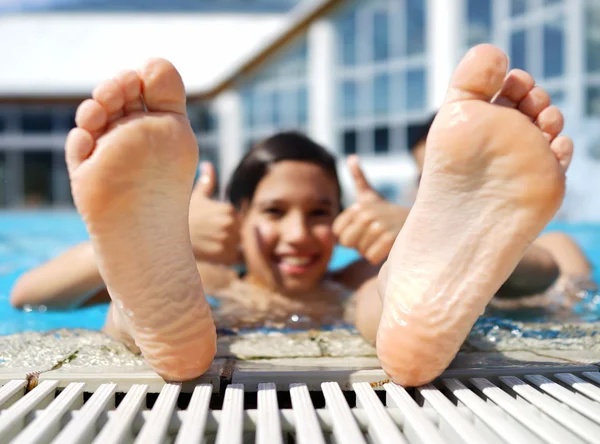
left=0, top=0, right=600, bottom=210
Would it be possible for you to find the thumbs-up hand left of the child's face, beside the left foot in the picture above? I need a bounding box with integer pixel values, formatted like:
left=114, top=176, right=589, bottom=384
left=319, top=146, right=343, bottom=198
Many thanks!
left=189, top=162, right=240, bottom=265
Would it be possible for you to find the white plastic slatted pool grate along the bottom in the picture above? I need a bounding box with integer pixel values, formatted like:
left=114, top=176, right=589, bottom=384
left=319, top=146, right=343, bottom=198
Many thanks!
left=0, top=371, right=600, bottom=444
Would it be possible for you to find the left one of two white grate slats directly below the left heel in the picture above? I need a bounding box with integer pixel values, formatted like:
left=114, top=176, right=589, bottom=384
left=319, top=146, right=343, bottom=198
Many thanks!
left=135, top=383, right=181, bottom=444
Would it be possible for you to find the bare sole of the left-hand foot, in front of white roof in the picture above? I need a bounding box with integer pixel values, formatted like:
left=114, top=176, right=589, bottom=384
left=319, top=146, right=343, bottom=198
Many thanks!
left=65, top=59, right=216, bottom=381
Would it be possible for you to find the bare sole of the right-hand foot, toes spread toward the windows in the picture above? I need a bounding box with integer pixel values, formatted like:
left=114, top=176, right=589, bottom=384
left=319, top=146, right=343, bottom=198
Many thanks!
left=377, top=45, right=573, bottom=386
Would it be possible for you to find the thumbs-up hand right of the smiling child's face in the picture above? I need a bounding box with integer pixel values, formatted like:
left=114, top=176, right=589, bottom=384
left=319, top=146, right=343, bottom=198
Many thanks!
left=333, top=155, right=409, bottom=264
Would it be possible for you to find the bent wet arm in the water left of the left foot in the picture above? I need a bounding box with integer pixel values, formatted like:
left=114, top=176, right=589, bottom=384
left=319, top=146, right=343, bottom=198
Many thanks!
left=10, top=242, right=105, bottom=308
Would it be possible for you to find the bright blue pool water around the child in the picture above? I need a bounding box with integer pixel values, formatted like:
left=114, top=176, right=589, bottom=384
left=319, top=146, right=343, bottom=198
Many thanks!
left=0, top=211, right=600, bottom=335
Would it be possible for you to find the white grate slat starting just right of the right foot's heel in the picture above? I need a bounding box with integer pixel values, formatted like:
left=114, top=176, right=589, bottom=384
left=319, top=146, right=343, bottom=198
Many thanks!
left=443, top=379, right=542, bottom=444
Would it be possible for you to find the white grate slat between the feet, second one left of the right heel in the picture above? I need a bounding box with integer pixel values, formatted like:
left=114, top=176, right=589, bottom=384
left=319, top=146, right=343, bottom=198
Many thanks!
left=321, top=382, right=366, bottom=444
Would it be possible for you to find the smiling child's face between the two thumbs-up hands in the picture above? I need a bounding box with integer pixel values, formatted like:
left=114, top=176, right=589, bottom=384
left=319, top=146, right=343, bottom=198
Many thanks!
left=241, top=161, right=340, bottom=294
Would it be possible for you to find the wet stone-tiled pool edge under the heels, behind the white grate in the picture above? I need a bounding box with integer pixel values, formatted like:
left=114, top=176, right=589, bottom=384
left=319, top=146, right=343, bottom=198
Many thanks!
left=0, top=324, right=600, bottom=392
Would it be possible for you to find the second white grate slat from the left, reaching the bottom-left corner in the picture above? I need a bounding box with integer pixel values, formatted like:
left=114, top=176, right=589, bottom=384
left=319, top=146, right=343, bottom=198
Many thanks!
left=0, top=381, right=58, bottom=442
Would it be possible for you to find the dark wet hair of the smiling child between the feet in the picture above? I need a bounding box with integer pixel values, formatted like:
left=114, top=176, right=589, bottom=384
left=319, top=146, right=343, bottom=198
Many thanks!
left=226, top=131, right=342, bottom=209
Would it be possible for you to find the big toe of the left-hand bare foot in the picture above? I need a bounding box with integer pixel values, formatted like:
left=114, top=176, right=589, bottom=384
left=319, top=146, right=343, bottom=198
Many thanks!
left=140, top=58, right=186, bottom=115
